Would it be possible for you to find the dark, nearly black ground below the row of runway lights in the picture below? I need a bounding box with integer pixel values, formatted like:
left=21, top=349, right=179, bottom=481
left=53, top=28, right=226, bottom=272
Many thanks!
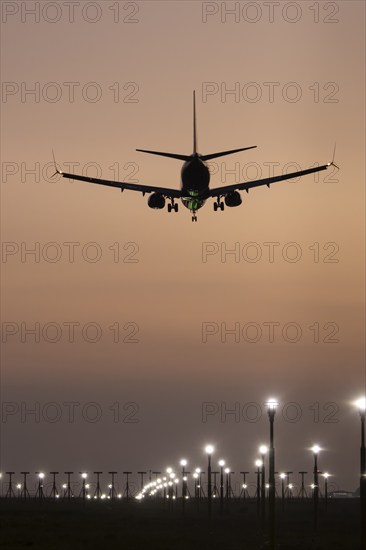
left=0, top=498, right=360, bottom=550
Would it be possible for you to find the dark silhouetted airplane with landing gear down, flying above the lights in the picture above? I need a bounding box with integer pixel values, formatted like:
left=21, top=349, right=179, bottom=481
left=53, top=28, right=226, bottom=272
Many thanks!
left=53, top=91, right=339, bottom=222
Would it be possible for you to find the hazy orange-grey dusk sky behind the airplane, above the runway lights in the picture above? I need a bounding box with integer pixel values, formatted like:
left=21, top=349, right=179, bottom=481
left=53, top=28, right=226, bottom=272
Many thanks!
left=1, top=0, right=365, bottom=496
